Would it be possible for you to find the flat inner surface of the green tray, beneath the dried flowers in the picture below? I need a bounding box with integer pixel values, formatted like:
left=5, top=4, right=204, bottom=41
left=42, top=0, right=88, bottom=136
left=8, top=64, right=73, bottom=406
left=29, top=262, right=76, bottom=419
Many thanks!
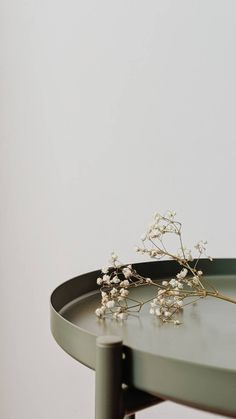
left=60, top=273, right=236, bottom=371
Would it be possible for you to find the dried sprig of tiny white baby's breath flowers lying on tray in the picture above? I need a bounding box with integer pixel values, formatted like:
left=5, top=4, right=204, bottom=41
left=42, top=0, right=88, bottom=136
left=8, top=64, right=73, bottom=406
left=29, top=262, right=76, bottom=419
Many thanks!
left=95, top=211, right=236, bottom=325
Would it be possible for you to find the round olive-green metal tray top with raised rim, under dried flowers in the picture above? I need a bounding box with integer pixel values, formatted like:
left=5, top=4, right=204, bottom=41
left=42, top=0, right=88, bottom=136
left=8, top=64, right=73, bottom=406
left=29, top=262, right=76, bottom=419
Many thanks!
left=51, top=259, right=236, bottom=417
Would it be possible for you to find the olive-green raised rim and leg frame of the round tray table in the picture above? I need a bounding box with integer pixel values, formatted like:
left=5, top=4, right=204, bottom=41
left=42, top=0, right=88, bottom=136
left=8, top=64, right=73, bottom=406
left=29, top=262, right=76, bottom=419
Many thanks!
left=50, top=259, right=236, bottom=419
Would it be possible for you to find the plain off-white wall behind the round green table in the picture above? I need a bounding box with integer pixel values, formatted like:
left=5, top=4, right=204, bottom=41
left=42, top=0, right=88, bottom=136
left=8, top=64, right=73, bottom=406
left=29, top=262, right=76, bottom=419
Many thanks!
left=0, top=0, right=236, bottom=419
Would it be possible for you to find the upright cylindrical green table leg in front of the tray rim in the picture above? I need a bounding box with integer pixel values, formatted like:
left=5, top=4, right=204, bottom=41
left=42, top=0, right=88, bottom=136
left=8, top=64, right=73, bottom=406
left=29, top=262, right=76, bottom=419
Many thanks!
left=95, top=336, right=123, bottom=419
